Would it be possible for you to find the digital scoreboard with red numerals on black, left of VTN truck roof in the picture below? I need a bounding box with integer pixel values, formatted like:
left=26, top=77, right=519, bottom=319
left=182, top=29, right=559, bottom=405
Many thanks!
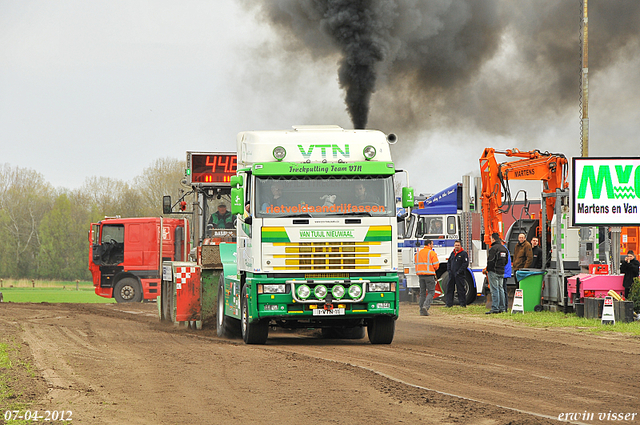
left=186, top=152, right=238, bottom=185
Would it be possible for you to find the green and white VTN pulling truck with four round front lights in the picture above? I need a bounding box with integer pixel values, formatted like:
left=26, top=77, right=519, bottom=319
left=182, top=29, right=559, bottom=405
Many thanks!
left=217, top=126, right=413, bottom=344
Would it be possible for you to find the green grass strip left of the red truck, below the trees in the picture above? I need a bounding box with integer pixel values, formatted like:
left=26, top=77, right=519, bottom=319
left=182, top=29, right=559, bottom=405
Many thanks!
left=0, top=279, right=115, bottom=303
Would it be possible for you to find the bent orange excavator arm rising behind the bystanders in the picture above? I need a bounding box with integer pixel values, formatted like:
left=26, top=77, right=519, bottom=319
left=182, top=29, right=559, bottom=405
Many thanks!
left=480, top=148, right=569, bottom=245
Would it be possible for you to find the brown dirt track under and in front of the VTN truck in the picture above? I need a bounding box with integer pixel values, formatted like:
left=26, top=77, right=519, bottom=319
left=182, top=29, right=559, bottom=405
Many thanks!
left=0, top=303, right=640, bottom=424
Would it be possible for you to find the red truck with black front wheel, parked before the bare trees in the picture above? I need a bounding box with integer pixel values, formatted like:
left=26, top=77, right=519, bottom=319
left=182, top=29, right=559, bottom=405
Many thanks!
left=89, top=217, right=190, bottom=303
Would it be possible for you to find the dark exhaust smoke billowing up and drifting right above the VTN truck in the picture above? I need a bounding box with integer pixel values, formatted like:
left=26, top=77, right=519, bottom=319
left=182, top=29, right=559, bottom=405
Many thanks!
left=245, top=0, right=640, bottom=135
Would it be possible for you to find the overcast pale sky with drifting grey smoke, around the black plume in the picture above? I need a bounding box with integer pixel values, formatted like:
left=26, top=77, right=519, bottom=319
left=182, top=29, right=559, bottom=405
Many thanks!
left=0, top=0, right=640, bottom=193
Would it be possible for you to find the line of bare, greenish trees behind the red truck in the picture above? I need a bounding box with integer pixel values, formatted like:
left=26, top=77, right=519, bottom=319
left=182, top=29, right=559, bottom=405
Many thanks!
left=0, top=158, right=186, bottom=280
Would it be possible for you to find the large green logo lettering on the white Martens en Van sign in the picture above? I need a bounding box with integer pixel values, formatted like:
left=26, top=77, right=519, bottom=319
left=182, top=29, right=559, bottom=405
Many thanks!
left=578, top=165, right=640, bottom=199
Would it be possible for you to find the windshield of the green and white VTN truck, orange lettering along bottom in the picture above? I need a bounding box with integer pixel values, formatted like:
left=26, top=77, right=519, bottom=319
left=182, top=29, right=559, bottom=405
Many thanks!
left=255, top=176, right=396, bottom=217
